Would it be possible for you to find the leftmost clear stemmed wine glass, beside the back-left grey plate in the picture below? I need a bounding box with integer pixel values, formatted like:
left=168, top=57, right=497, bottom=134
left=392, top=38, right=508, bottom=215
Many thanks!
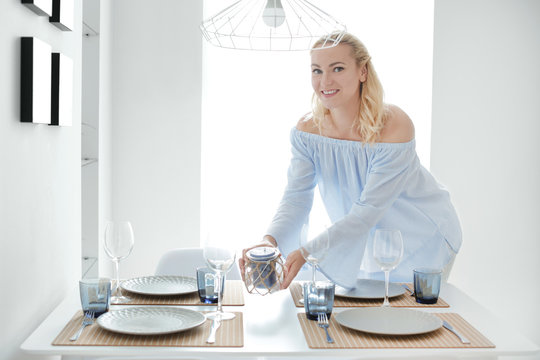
left=103, top=221, right=135, bottom=304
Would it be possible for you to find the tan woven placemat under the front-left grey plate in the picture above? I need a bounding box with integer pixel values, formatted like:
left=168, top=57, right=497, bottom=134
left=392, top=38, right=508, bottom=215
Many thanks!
left=52, top=311, right=244, bottom=347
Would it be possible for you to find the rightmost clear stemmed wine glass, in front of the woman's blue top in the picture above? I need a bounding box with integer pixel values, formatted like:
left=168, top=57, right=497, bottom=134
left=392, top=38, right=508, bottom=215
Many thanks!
left=373, top=229, right=403, bottom=307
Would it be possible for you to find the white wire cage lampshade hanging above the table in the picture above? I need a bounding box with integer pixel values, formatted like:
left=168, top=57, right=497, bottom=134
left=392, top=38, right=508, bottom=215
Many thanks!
left=200, top=0, right=346, bottom=51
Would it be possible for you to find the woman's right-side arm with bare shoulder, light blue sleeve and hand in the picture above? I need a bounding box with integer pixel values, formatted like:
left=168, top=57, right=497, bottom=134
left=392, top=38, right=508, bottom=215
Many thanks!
left=283, top=105, right=418, bottom=288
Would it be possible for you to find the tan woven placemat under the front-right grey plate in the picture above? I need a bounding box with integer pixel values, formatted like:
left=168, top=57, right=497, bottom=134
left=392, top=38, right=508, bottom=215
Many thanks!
left=298, top=313, right=495, bottom=349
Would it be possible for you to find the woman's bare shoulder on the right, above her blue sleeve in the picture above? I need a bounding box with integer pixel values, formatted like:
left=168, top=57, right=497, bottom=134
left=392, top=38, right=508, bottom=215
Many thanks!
left=380, top=104, right=414, bottom=143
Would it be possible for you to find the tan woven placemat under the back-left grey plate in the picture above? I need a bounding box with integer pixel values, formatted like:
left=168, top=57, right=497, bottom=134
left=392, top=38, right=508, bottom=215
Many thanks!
left=115, top=280, right=244, bottom=306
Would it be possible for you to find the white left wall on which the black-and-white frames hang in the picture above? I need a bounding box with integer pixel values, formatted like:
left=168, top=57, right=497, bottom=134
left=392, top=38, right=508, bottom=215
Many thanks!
left=0, top=0, right=81, bottom=359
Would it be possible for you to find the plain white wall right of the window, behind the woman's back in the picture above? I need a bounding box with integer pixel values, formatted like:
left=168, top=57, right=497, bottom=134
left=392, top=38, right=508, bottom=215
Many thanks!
left=431, top=0, right=540, bottom=344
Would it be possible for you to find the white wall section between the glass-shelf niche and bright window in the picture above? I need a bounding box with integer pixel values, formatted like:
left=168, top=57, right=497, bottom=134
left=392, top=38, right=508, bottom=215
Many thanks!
left=106, top=0, right=202, bottom=277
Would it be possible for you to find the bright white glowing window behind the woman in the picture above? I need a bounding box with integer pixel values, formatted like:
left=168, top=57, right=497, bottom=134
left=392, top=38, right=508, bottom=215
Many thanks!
left=201, top=0, right=433, bottom=249
